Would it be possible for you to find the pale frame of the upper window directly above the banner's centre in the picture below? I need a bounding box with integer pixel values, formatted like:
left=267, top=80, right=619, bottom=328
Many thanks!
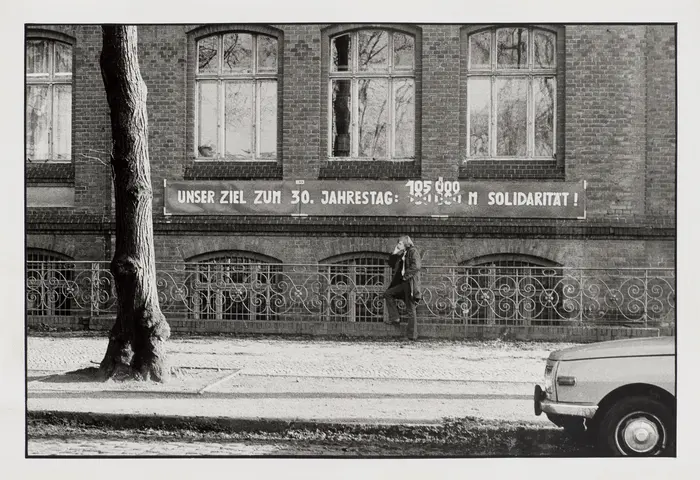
left=324, top=25, right=420, bottom=163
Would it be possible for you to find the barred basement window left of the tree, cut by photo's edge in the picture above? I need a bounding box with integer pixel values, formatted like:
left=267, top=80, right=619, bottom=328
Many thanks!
left=26, top=249, right=74, bottom=316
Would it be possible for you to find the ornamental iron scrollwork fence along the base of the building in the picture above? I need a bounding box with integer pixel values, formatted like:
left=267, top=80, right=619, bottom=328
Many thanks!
left=26, top=260, right=676, bottom=327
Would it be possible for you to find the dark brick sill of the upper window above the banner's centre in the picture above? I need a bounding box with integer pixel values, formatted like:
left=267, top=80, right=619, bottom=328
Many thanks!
left=318, top=160, right=421, bottom=180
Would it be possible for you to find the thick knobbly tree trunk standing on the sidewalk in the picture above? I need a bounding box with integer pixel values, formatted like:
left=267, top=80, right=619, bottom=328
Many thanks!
left=100, top=25, right=170, bottom=381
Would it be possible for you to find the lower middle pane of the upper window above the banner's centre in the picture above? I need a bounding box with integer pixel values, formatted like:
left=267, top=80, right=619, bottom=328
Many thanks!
left=358, top=79, right=389, bottom=158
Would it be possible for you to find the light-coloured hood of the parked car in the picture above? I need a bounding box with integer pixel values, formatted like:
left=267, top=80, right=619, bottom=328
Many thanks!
left=549, top=337, right=676, bottom=360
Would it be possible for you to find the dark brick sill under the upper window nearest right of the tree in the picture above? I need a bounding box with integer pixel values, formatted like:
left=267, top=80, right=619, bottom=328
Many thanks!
left=184, top=160, right=282, bottom=180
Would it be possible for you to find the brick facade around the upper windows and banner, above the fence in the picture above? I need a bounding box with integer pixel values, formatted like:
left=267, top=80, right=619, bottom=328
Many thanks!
left=27, top=25, right=675, bottom=272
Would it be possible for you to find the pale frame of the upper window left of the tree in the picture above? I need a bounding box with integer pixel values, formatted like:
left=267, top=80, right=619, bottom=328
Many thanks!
left=24, top=35, right=75, bottom=164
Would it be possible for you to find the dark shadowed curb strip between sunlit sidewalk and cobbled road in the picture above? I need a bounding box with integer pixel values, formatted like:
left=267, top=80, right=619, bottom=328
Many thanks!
left=26, top=411, right=587, bottom=456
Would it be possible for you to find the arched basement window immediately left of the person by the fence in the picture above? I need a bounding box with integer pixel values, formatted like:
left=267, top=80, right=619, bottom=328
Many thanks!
left=319, top=252, right=388, bottom=322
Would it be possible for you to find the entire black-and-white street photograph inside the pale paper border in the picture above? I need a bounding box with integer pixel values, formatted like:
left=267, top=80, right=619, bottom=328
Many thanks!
left=6, top=3, right=696, bottom=478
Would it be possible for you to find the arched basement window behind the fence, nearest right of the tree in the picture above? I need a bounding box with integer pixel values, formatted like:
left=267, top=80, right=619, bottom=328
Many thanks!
left=189, top=251, right=281, bottom=320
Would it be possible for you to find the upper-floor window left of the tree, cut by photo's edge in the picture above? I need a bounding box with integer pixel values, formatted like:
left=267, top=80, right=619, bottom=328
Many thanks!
left=25, top=38, right=73, bottom=162
